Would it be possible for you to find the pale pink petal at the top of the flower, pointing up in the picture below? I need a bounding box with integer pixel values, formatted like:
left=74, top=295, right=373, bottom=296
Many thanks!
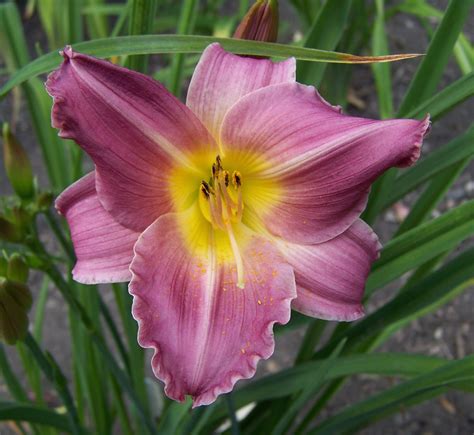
left=186, top=43, right=296, bottom=140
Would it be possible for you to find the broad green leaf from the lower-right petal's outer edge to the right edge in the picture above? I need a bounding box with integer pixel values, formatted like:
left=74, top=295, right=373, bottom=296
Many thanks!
left=366, top=201, right=474, bottom=296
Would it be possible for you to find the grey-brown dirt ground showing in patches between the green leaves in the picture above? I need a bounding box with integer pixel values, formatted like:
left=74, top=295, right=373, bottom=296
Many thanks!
left=0, top=0, right=474, bottom=435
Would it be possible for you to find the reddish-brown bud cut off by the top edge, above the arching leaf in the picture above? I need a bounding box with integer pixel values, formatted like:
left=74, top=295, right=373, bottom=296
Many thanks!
left=234, top=0, right=278, bottom=42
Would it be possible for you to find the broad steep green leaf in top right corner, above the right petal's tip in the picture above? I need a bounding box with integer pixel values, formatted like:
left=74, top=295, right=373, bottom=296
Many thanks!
left=398, top=0, right=474, bottom=116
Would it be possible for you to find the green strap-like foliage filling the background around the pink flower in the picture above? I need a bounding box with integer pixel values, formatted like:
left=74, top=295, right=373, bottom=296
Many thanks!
left=0, top=0, right=474, bottom=434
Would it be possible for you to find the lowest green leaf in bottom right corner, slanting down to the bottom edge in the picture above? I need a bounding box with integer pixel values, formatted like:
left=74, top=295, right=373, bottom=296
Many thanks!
left=309, top=355, right=474, bottom=435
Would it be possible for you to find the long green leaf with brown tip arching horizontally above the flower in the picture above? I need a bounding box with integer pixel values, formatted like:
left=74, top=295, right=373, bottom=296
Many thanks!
left=0, top=35, right=418, bottom=98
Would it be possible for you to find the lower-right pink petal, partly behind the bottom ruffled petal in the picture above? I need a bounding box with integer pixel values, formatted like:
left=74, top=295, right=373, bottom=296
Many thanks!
left=277, top=219, right=381, bottom=321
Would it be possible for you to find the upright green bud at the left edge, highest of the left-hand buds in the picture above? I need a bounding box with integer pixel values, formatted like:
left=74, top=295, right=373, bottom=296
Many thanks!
left=3, top=123, right=34, bottom=199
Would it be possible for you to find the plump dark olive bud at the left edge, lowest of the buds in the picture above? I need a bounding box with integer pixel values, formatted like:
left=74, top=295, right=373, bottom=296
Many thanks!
left=0, top=278, right=33, bottom=344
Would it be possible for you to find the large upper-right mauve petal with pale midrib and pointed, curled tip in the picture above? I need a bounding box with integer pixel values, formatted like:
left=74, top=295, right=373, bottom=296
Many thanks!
left=221, top=83, right=429, bottom=244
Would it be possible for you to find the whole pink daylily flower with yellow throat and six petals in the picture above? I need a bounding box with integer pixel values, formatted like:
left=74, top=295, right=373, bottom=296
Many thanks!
left=46, top=44, right=429, bottom=406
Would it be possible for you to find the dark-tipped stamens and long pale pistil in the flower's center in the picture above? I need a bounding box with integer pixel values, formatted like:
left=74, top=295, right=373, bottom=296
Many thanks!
left=199, top=156, right=245, bottom=288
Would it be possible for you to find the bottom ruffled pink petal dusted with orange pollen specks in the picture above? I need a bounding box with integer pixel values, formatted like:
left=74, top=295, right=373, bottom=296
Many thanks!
left=130, top=206, right=296, bottom=406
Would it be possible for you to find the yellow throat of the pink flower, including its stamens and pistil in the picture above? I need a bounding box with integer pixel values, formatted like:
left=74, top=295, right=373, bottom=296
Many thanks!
left=169, top=151, right=282, bottom=288
